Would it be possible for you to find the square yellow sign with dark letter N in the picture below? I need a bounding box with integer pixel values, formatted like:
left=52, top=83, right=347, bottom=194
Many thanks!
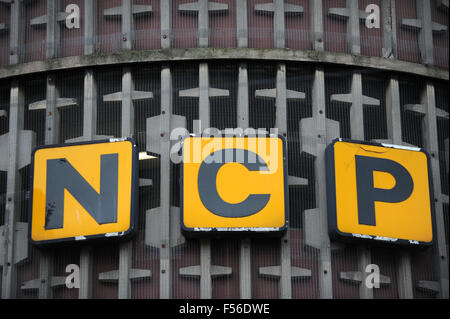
left=29, top=139, right=138, bottom=245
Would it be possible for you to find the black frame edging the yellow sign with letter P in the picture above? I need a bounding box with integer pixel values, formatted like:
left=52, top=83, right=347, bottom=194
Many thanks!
left=325, top=138, right=436, bottom=248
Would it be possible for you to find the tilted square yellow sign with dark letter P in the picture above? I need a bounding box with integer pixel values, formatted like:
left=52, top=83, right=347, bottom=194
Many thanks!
left=326, top=139, right=434, bottom=245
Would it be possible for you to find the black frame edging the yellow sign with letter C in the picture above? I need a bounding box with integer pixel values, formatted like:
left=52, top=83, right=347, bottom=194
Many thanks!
left=180, top=133, right=289, bottom=238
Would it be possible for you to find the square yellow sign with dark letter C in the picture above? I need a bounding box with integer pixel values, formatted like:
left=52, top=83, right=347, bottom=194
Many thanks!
left=181, top=137, right=288, bottom=234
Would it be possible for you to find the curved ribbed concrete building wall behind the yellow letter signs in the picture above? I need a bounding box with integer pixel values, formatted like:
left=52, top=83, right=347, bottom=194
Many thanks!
left=0, top=0, right=449, bottom=299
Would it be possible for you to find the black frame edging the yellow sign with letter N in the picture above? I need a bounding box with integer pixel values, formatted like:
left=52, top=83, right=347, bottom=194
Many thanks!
left=28, top=138, right=139, bottom=248
